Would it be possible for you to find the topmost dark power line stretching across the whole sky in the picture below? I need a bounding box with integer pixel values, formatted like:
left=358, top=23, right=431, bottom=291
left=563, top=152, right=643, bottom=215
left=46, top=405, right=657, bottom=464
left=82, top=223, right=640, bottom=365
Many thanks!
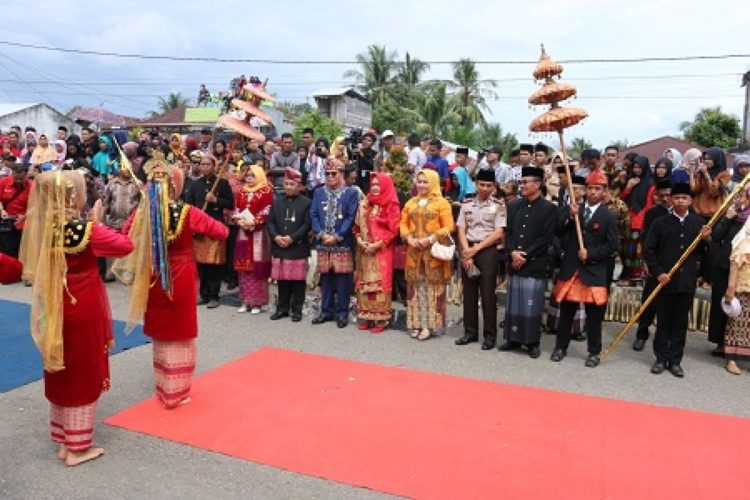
left=0, top=40, right=750, bottom=65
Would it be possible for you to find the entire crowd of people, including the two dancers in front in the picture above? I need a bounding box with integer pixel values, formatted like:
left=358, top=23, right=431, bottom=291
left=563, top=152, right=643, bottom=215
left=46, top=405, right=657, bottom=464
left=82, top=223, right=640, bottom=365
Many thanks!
left=0, top=120, right=750, bottom=465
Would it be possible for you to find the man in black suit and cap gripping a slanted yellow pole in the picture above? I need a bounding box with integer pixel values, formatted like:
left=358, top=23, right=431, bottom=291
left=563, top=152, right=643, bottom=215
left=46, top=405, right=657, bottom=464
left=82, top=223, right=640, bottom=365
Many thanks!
left=643, top=184, right=711, bottom=377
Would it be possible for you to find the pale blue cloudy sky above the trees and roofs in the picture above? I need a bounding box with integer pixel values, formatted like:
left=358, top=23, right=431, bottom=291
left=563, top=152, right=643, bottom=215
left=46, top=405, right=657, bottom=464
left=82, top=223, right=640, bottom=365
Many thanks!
left=0, top=0, right=750, bottom=147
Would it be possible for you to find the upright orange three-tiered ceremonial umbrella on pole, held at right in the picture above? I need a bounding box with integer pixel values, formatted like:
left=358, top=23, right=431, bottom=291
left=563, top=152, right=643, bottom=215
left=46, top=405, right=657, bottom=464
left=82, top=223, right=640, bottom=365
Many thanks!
left=529, top=45, right=588, bottom=248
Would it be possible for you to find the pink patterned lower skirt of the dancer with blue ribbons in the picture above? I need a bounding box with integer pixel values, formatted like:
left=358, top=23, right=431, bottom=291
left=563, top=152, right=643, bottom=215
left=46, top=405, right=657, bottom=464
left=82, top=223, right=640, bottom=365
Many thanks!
left=153, top=339, right=196, bottom=409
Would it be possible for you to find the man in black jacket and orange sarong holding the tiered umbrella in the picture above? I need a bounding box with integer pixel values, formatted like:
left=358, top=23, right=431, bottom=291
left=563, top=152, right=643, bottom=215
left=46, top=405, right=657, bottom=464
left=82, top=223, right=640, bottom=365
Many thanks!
left=550, top=168, right=619, bottom=368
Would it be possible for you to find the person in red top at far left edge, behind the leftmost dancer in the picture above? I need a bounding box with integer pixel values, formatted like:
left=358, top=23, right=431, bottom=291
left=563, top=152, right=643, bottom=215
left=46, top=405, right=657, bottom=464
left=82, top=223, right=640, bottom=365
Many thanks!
left=0, top=163, right=31, bottom=258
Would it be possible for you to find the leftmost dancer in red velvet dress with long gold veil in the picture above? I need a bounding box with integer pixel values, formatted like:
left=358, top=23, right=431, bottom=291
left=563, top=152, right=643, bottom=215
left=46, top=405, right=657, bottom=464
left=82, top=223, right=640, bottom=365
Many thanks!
left=20, top=171, right=133, bottom=466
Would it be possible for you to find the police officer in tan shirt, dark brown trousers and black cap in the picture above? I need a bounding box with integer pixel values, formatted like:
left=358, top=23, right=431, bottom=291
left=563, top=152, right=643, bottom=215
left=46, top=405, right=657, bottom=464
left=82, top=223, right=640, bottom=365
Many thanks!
left=456, top=169, right=506, bottom=351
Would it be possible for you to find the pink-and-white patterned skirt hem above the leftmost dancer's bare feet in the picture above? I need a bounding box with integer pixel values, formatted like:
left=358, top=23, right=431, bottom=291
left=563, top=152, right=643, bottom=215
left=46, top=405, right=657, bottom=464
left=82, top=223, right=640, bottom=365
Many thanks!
left=49, top=401, right=96, bottom=453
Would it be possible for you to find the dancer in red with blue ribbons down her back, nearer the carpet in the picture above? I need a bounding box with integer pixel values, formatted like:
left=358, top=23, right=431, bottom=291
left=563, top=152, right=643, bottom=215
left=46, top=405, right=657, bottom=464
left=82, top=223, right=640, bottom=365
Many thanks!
left=112, top=153, right=229, bottom=409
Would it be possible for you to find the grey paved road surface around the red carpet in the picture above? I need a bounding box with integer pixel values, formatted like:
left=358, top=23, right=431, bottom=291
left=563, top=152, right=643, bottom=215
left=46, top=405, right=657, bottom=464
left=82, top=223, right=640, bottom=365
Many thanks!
left=0, top=284, right=750, bottom=499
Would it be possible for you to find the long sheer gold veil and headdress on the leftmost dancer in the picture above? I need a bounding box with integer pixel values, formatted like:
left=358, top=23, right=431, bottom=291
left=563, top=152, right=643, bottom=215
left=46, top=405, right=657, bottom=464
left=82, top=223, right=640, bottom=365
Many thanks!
left=20, top=170, right=86, bottom=372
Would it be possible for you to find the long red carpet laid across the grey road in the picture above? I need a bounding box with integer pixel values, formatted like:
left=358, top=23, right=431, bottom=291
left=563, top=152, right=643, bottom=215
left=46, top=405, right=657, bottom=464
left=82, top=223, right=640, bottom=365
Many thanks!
left=107, top=349, right=750, bottom=500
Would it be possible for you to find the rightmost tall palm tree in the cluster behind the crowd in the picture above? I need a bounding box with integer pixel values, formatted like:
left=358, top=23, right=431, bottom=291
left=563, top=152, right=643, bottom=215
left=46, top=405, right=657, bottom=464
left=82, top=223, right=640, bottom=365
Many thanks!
left=450, top=59, right=497, bottom=127
